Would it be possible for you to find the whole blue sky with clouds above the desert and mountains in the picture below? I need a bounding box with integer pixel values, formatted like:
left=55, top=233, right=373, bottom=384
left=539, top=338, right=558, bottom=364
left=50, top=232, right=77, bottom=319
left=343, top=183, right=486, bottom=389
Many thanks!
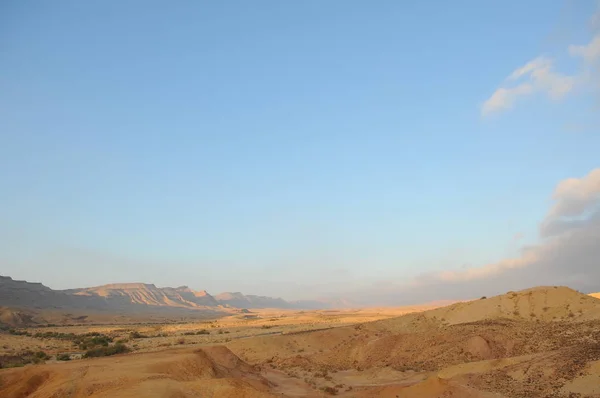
left=0, top=0, right=600, bottom=303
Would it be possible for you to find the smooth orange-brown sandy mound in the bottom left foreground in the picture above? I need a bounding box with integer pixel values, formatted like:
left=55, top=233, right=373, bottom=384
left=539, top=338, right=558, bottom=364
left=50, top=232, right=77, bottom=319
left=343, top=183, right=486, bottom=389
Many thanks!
left=0, top=346, right=275, bottom=398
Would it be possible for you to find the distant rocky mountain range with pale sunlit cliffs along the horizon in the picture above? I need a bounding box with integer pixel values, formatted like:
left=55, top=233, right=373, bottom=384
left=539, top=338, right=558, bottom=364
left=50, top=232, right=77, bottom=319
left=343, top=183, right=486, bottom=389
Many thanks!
left=0, top=276, right=333, bottom=311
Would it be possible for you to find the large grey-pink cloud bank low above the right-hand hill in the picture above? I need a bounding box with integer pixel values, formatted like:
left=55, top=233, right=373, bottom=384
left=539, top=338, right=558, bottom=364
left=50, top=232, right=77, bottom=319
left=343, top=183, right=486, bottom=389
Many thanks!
left=350, top=168, right=600, bottom=305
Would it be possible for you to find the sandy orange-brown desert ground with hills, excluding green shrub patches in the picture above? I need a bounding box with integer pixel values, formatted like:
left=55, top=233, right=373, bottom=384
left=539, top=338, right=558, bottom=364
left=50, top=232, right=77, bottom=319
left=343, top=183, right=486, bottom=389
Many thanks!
left=0, top=287, right=600, bottom=398
